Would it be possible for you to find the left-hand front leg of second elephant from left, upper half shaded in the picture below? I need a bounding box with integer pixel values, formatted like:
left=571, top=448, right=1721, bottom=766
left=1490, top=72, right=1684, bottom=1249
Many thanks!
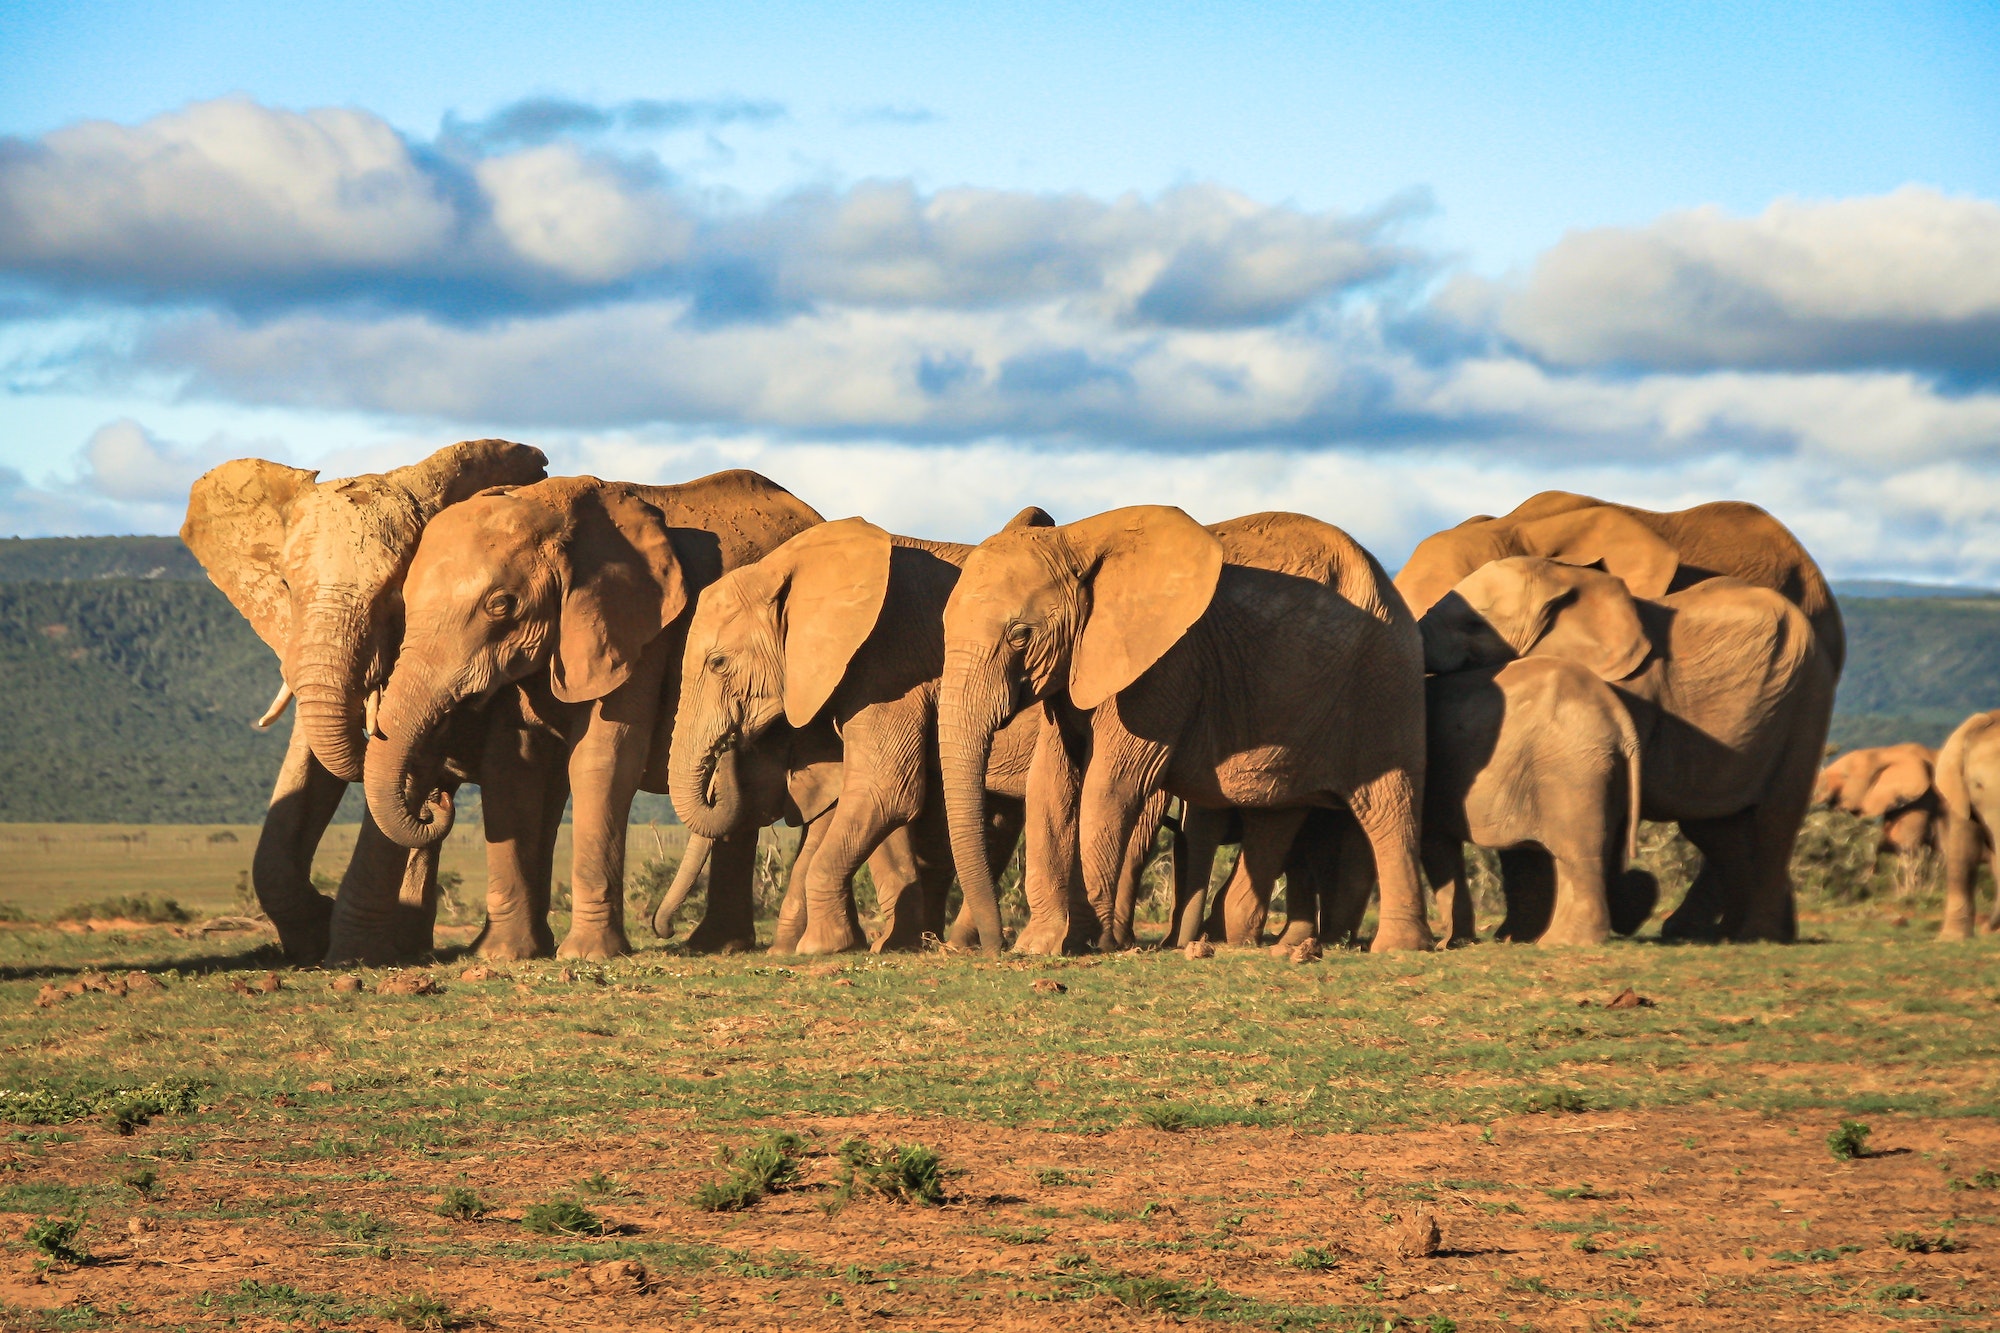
left=472, top=721, right=568, bottom=959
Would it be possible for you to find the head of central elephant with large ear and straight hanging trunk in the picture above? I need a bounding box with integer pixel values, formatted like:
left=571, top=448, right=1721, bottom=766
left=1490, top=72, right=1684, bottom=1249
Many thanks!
left=938, top=504, right=1222, bottom=953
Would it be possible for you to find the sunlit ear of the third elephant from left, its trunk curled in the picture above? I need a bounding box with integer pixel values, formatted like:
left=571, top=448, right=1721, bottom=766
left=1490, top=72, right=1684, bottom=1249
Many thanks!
left=764, top=518, right=892, bottom=727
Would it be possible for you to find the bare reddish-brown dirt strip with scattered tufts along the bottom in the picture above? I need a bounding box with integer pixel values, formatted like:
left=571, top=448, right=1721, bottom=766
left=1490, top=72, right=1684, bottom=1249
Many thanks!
left=0, top=1109, right=2000, bottom=1331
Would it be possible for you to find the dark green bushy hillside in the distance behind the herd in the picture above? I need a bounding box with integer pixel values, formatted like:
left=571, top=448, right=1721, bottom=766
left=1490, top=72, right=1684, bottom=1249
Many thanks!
left=0, top=536, right=2000, bottom=823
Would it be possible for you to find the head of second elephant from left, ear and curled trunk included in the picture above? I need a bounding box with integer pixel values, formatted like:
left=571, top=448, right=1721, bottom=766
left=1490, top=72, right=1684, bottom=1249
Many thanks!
left=366, top=476, right=688, bottom=847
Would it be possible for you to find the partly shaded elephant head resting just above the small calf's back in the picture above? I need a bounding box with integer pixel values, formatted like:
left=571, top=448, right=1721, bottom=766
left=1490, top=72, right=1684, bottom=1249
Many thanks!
left=1418, top=556, right=1652, bottom=681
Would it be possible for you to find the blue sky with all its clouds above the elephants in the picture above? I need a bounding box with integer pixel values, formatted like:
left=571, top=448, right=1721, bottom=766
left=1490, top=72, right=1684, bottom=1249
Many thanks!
left=0, top=4, right=2000, bottom=580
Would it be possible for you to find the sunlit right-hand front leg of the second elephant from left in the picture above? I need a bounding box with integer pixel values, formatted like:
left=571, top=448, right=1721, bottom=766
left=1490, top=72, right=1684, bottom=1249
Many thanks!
left=556, top=704, right=648, bottom=959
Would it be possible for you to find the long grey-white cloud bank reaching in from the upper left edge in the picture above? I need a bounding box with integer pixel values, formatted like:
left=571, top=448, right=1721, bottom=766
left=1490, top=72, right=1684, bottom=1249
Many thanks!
left=0, top=100, right=1422, bottom=326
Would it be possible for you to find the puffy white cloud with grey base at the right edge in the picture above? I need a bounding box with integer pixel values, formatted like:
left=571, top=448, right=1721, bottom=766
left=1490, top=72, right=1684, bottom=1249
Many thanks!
left=1504, top=186, right=2000, bottom=378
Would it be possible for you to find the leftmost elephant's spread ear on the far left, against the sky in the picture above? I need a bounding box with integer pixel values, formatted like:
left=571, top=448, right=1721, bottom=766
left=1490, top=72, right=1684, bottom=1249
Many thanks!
left=180, top=458, right=320, bottom=658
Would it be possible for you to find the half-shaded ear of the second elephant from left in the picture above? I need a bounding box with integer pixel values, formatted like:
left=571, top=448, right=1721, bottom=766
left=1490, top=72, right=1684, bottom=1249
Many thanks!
left=550, top=478, right=688, bottom=703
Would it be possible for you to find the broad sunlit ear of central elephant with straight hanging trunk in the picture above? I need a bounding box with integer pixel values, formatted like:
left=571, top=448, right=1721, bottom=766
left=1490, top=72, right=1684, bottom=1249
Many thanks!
left=1062, top=504, right=1222, bottom=709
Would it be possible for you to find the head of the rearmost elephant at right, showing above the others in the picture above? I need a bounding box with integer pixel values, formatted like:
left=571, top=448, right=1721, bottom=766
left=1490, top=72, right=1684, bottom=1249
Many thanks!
left=1396, top=496, right=1680, bottom=614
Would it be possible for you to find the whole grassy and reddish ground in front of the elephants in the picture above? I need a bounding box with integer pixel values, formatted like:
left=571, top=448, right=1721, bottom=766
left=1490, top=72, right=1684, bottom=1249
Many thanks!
left=0, top=816, right=2000, bottom=1331
